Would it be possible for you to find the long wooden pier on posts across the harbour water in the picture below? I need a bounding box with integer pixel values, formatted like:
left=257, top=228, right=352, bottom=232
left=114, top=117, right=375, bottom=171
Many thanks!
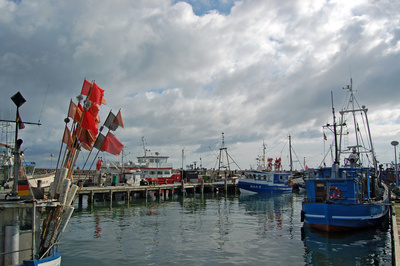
left=77, top=181, right=240, bottom=205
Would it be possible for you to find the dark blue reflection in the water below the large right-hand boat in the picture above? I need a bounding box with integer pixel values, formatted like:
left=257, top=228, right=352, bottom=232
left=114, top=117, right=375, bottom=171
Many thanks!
left=302, top=219, right=392, bottom=265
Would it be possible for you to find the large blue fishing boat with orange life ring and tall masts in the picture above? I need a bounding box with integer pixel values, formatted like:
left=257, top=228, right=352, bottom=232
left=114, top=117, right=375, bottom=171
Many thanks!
left=301, top=80, right=390, bottom=232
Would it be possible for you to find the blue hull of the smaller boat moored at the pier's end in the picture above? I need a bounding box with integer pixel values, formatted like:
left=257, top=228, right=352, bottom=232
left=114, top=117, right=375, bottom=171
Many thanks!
left=238, top=179, right=292, bottom=194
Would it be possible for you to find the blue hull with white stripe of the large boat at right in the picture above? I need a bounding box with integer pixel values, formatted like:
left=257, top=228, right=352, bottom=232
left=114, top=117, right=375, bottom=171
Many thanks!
left=301, top=202, right=389, bottom=232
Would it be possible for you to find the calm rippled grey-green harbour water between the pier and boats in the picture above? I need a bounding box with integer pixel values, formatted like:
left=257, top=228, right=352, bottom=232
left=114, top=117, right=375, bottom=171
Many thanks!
left=59, top=193, right=391, bottom=266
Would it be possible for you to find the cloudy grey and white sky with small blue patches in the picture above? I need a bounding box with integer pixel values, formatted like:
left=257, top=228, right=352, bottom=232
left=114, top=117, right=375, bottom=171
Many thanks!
left=0, top=0, right=400, bottom=170
